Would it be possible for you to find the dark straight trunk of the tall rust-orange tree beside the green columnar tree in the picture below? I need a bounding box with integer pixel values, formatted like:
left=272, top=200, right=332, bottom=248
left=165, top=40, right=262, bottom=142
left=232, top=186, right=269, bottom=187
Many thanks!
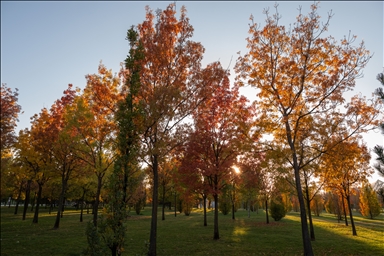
left=148, top=155, right=159, bottom=256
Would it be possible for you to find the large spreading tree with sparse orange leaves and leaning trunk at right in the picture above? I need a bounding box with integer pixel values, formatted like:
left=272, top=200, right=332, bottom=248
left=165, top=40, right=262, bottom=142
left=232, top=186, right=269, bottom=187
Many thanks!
left=235, top=3, right=378, bottom=255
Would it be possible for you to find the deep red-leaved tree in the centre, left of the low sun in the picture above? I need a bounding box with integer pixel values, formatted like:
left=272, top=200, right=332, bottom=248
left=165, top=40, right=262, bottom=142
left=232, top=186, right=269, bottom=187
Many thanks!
left=181, top=77, right=251, bottom=239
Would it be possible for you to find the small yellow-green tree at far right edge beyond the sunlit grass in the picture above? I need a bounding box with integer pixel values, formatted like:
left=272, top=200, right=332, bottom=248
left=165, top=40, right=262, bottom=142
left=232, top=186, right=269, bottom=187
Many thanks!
left=359, top=183, right=380, bottom=219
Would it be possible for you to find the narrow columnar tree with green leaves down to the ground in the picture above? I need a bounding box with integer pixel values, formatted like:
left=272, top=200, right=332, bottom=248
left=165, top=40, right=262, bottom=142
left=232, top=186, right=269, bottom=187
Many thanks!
left=87, top=27, right=144, bottom=256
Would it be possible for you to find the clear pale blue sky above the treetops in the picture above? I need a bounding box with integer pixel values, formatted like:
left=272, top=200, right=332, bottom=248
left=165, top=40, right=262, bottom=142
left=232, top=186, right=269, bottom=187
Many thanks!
left=1, top=1, right=384, bottom=181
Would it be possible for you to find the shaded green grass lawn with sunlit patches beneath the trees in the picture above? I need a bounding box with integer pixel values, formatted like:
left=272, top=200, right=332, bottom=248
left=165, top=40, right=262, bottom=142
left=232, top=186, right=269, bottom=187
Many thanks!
left=1, top=206, right=384, bottom=256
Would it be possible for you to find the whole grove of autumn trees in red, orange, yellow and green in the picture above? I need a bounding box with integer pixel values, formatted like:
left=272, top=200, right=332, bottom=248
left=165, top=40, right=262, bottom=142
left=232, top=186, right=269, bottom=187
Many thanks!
left=1, top=3, right=384, bottom=256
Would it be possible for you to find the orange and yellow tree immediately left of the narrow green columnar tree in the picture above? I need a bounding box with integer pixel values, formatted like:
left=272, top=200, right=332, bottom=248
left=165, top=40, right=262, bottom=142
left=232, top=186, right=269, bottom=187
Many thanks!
left=67, top=64, right=122, bottom=226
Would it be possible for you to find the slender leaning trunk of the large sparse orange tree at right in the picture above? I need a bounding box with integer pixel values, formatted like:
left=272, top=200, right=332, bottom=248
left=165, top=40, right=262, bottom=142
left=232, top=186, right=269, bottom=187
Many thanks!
left=284, top=120, right=313, bottom=256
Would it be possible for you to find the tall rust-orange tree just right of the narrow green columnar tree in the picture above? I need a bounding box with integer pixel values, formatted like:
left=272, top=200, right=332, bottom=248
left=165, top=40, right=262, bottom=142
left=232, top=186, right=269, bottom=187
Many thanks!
left=138, top=4, right=224, bottom=255
